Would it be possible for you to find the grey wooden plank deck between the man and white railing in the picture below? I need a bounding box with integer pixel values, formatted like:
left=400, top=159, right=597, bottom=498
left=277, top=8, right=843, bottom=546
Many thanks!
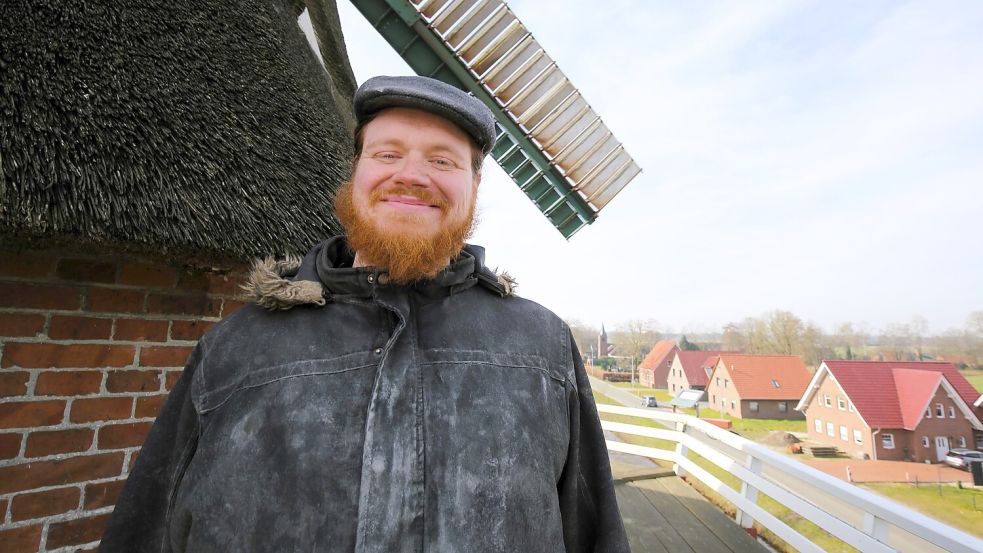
left=611, top=460, right=768, bottom=553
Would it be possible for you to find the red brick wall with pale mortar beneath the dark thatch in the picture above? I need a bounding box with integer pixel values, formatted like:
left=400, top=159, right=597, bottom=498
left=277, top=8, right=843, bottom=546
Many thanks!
left=0, top=251, right=241, bottom=553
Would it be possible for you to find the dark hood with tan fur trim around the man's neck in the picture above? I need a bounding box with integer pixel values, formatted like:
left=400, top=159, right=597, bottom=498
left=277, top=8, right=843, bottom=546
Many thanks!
left=242, top=237, right=518, bottom=310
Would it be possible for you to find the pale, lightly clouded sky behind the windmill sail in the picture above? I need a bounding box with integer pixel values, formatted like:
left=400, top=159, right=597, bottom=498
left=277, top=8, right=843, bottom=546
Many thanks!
left=318, top=0, right=983, bottom=333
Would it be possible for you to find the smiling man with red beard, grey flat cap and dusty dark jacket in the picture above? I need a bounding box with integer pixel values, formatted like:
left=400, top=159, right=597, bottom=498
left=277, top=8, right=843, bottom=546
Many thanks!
left=101, top=77, right=628, bottom=552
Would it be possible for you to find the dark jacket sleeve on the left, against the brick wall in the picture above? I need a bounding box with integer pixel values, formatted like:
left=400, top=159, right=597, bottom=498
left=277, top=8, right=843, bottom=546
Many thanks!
left=99, top=344, right=202, bottom=553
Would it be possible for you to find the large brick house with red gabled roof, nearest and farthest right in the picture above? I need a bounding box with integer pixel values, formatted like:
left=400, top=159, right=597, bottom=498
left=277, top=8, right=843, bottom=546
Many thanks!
left=795, top=361, right=983, bottom=463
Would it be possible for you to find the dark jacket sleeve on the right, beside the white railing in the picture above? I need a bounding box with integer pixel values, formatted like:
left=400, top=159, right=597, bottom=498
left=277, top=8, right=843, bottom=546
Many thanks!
left=558, top=333, right=630, bottom=553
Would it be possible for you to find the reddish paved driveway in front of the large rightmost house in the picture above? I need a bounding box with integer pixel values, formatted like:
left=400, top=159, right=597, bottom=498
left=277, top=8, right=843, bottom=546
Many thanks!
left=796, top=455, right=973, bottom=485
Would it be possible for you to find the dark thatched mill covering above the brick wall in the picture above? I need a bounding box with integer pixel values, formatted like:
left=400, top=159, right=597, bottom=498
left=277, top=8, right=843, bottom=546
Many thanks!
left=0, top=0, right=355, bottom=260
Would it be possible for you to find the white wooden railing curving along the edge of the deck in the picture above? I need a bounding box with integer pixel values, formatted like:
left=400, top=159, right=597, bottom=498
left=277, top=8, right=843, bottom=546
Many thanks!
left=597, top=404, right=983, bottom=553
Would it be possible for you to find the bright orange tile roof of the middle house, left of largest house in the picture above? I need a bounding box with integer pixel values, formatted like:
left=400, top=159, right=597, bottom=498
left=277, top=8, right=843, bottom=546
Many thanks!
left=718, top=353, right=812, bottom=400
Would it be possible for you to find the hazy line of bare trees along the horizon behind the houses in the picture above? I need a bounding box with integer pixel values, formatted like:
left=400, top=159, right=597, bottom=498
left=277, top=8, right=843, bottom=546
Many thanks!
left=567, top=310, right=983, bottom=368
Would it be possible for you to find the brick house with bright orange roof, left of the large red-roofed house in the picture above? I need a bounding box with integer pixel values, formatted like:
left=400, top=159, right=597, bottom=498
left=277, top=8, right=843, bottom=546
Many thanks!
left=706, top=353, right=812, bottom=419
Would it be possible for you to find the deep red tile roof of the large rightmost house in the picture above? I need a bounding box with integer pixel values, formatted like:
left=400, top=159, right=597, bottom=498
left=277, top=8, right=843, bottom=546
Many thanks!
left=824, top=361, right=983, bottom=429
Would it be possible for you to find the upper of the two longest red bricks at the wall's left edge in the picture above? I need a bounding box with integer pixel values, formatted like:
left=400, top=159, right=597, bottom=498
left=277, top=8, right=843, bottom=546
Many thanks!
left=0, top=343, right=134, bottom=369
